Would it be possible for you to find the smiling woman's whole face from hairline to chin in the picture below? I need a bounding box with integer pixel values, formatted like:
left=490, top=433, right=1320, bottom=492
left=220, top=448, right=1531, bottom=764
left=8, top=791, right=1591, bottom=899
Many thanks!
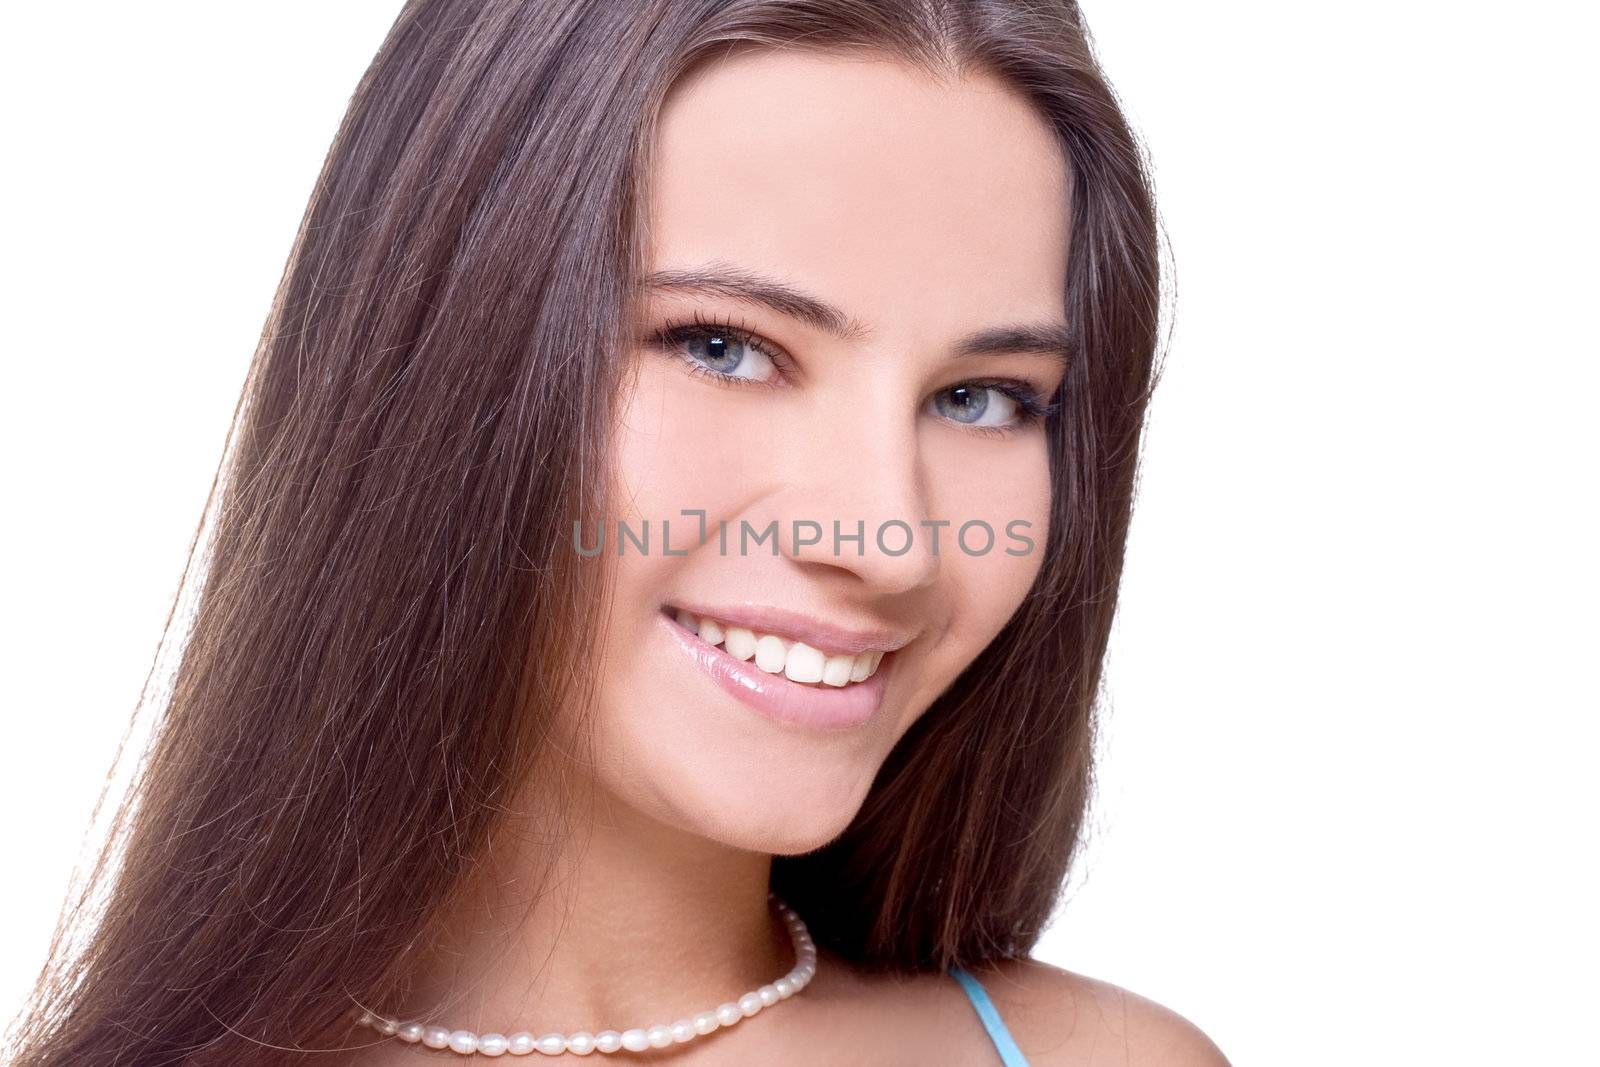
left=584, top=53, right=1069, bottom=854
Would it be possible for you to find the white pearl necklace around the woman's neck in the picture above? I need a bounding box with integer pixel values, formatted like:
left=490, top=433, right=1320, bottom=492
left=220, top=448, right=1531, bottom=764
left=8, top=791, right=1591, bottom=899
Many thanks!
left=357, top=893, right=816, bottom=1056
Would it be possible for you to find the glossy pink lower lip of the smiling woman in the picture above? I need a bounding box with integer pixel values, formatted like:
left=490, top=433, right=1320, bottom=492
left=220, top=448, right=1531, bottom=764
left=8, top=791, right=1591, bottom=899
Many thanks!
left=656, top=613, right=894, bottom=729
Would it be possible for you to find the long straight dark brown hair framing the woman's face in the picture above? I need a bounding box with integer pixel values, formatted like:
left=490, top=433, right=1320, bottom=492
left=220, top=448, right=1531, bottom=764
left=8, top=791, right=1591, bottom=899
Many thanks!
left=13, top=0, right=1162, bottom=1067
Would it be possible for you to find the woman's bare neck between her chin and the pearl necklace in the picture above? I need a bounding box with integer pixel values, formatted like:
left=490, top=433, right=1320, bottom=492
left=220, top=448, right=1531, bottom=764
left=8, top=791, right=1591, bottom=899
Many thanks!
left=395, top=767, right=794, bottom=1035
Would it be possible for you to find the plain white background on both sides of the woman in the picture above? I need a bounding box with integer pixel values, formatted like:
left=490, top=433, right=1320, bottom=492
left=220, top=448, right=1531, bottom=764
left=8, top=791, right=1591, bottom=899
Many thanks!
left=0, top=0, right=1600, bottom=1067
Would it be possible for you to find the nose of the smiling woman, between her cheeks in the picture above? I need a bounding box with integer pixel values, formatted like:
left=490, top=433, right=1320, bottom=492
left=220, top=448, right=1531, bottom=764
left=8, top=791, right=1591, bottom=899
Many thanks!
left=781, top=403, right=950, bottom=595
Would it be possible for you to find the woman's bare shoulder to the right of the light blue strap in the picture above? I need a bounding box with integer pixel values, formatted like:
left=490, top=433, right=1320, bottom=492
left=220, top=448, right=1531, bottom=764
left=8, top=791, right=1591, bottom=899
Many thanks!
left=971, top=960, right=1230, bottom=1067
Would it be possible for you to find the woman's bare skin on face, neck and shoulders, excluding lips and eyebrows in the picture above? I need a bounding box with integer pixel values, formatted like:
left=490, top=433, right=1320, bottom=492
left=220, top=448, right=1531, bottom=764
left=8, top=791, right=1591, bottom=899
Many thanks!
left=344, top=51, right=1226, bottom=1067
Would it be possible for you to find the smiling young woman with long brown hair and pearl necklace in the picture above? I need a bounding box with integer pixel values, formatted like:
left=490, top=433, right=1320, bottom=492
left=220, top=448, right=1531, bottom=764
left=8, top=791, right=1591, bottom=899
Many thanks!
left=16, top=0, right=1226, bottom=1067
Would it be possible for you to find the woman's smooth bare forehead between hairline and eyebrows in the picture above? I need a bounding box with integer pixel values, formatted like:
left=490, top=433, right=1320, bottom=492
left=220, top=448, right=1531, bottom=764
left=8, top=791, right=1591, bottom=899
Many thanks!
left=648, top=51, right=1070, bottom=338
